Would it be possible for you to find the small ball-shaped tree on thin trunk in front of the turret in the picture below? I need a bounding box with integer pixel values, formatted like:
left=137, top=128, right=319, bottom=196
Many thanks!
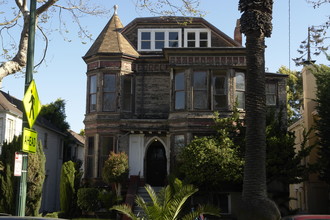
left=102, top=152, right=129, bottom=197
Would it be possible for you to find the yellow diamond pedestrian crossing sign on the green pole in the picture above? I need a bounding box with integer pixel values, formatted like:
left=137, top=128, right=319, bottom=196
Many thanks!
left=23, top=80, right=41, bottom=128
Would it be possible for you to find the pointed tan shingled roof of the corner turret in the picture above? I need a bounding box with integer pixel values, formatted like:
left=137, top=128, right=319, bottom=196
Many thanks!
left=84, top=13, right=139, bottom=58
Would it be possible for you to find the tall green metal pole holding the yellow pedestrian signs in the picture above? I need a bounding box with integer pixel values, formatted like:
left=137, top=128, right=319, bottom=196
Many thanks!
left=16, top=0, right=37, bottom=216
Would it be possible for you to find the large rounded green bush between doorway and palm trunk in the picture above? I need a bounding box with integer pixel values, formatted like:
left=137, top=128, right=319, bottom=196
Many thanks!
left=178, top=112, right=243, bottom=188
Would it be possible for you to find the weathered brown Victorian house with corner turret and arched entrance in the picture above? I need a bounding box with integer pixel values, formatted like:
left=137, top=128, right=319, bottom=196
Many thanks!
left=83, top=7, right=286, bottom=217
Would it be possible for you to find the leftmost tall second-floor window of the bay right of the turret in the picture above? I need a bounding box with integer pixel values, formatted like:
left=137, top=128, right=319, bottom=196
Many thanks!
left=174, top=70, right=186, bottom=110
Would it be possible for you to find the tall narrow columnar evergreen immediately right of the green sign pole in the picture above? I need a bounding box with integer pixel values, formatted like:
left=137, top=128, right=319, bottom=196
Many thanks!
left=25, top=141, right=46, bottom=216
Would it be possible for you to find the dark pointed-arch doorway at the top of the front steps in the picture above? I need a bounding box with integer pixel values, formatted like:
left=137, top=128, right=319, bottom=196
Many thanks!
left=146, top=139, right=167, bottom=186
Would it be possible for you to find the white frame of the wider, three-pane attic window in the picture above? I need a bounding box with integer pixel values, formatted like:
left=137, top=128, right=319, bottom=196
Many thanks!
left=138, top=28, right=182, bottom=51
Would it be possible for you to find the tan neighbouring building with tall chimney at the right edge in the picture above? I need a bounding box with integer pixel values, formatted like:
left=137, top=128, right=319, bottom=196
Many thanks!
left=288, top=66, right=330, bottom=213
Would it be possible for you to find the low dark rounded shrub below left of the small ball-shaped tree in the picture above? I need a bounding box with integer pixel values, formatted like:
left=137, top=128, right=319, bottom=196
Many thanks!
left=77, top=188, right=99, bottom=212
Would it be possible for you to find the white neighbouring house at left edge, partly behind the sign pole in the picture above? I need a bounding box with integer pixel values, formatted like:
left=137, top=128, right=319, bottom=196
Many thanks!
left=0, top=91, right=66, bottom=212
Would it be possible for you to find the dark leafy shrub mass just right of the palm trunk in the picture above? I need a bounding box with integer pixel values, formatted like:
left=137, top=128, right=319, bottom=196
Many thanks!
left=266, top=113, right=314, bottom=185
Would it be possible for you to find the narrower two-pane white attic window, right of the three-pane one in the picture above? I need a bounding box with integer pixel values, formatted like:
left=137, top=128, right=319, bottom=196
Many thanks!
left=184, top=28, right=211, bottom=47
